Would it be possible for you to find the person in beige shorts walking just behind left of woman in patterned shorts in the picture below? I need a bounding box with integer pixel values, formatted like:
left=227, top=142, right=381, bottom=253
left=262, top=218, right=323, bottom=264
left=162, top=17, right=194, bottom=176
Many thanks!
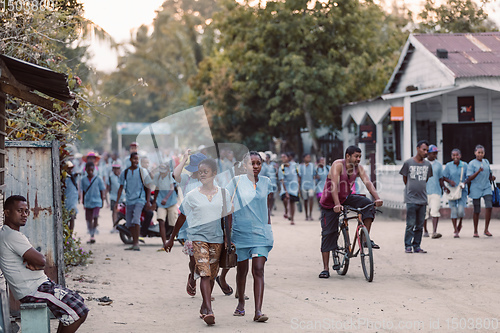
left=153, top=163, right=177, bottom=249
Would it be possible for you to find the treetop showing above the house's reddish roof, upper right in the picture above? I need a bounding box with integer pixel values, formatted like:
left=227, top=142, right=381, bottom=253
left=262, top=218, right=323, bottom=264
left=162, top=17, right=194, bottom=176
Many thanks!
left=416, top=0, right=498, bottom=33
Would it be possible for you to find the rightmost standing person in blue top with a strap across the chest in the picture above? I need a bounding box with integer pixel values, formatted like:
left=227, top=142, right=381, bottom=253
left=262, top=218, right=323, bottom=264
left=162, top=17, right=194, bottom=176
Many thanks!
left=466, top=145, right=496, bottom=238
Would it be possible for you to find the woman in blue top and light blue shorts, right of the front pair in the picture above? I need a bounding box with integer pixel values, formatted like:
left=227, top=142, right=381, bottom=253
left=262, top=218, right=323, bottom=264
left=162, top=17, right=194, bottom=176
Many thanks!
left=227, top=151, right=273, bottom=322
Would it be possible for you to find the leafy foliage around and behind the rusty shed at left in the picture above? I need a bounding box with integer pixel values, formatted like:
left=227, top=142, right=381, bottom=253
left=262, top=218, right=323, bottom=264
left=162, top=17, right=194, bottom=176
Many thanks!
left=0, top=0, right=102, bottom=268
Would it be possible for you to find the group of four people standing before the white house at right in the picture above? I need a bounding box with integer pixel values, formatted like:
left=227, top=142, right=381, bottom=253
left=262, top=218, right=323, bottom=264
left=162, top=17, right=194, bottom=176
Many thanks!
left=400, top=140, right=496, bottom=253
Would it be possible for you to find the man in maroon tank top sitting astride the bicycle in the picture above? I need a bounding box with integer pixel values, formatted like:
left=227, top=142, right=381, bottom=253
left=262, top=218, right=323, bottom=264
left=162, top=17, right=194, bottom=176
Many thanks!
left=319, top=146, right=383, bottom=278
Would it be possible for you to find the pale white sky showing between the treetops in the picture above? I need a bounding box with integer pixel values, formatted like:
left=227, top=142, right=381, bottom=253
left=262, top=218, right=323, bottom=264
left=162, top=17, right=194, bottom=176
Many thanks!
left=81, top=0, right=500, bottom=72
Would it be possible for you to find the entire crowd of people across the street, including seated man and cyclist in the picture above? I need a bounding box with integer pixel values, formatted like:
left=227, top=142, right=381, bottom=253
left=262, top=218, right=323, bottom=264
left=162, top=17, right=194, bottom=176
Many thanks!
left=0, top=140, right=495, bottom=332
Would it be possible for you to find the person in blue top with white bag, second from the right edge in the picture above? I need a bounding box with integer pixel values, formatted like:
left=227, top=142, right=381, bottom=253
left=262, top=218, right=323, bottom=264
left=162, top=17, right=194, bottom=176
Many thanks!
left=443, top=148, right=467, bottom=238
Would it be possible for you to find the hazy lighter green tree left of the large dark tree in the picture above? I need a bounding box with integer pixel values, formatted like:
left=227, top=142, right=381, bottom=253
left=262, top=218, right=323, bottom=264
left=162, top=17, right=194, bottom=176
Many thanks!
left=85, top=0, right=218, bottom=149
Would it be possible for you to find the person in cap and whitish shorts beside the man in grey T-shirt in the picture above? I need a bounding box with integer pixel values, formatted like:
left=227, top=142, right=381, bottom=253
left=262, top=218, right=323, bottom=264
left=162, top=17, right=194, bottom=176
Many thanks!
left=424, top=145, right=448, bottom=239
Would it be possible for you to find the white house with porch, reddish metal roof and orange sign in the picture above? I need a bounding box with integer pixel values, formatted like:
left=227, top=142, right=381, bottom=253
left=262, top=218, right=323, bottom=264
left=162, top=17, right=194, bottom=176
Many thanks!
left=342, top=32, right=500, bottom=164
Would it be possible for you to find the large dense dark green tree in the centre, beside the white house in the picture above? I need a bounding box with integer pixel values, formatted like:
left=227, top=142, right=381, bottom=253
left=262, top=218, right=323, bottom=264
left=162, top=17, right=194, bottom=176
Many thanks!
left=193, top=0, right=406, bottom=151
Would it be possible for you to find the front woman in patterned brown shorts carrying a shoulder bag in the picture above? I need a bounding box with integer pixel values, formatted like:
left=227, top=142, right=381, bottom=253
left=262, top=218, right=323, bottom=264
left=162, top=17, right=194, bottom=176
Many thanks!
left=165, top=158, right=232, bottom=325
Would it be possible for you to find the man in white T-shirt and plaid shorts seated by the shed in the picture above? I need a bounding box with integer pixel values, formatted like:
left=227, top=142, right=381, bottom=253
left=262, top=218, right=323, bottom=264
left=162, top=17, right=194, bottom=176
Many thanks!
left=0, top=195, right=89, bottom=333
